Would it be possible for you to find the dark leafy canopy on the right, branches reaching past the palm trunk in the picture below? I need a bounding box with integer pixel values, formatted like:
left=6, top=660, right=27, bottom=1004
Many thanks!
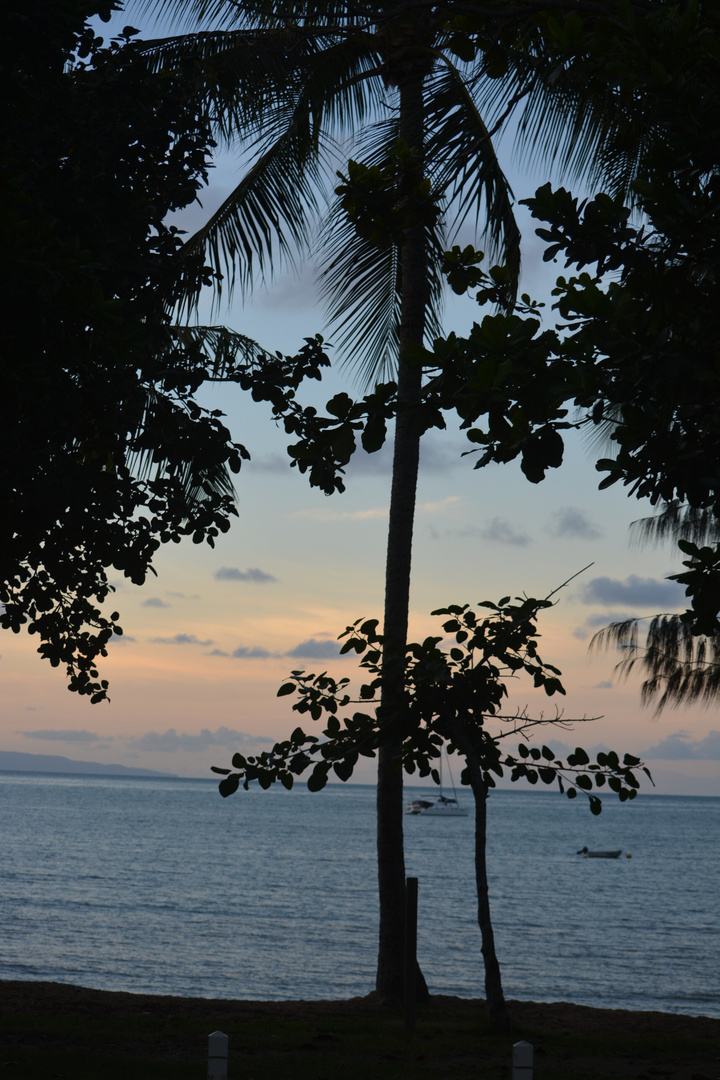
left=269, top=3, right=720, bottom=707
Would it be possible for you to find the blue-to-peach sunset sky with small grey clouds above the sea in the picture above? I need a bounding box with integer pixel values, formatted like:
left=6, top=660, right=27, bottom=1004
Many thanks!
left=0, top=8, right=720, bottom=795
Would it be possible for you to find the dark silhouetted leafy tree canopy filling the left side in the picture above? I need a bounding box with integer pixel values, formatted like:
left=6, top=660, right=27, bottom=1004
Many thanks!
left=0, top=0, right=317, bottom=701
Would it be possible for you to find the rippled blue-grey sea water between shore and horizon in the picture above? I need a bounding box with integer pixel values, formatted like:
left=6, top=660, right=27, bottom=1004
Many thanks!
left=0, top=772, right=720, bottom=1016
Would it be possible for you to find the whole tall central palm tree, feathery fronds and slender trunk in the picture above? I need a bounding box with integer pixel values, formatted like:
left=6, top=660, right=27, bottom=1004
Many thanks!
left=132, top=0, right=639, bottom=1000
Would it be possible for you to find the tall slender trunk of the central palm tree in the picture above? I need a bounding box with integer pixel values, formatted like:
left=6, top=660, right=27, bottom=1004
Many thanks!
left=376, top=65, right=427, bottom=1001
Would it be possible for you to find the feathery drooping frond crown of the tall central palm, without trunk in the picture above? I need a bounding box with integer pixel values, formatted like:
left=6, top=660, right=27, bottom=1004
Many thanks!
left=129, top=0, right=643, bottom=381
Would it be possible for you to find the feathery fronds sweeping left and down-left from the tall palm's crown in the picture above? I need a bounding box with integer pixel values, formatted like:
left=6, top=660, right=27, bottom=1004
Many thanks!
left=134, top=30, right=378, bottom=307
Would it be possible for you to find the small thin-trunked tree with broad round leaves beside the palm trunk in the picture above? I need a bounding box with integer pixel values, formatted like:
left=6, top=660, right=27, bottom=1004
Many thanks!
left=214, top=596, right=652, bottom=1027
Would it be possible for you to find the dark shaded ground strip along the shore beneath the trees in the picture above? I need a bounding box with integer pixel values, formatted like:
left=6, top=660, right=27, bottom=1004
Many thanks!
left=0, top=982, right=720, bottom=1080
